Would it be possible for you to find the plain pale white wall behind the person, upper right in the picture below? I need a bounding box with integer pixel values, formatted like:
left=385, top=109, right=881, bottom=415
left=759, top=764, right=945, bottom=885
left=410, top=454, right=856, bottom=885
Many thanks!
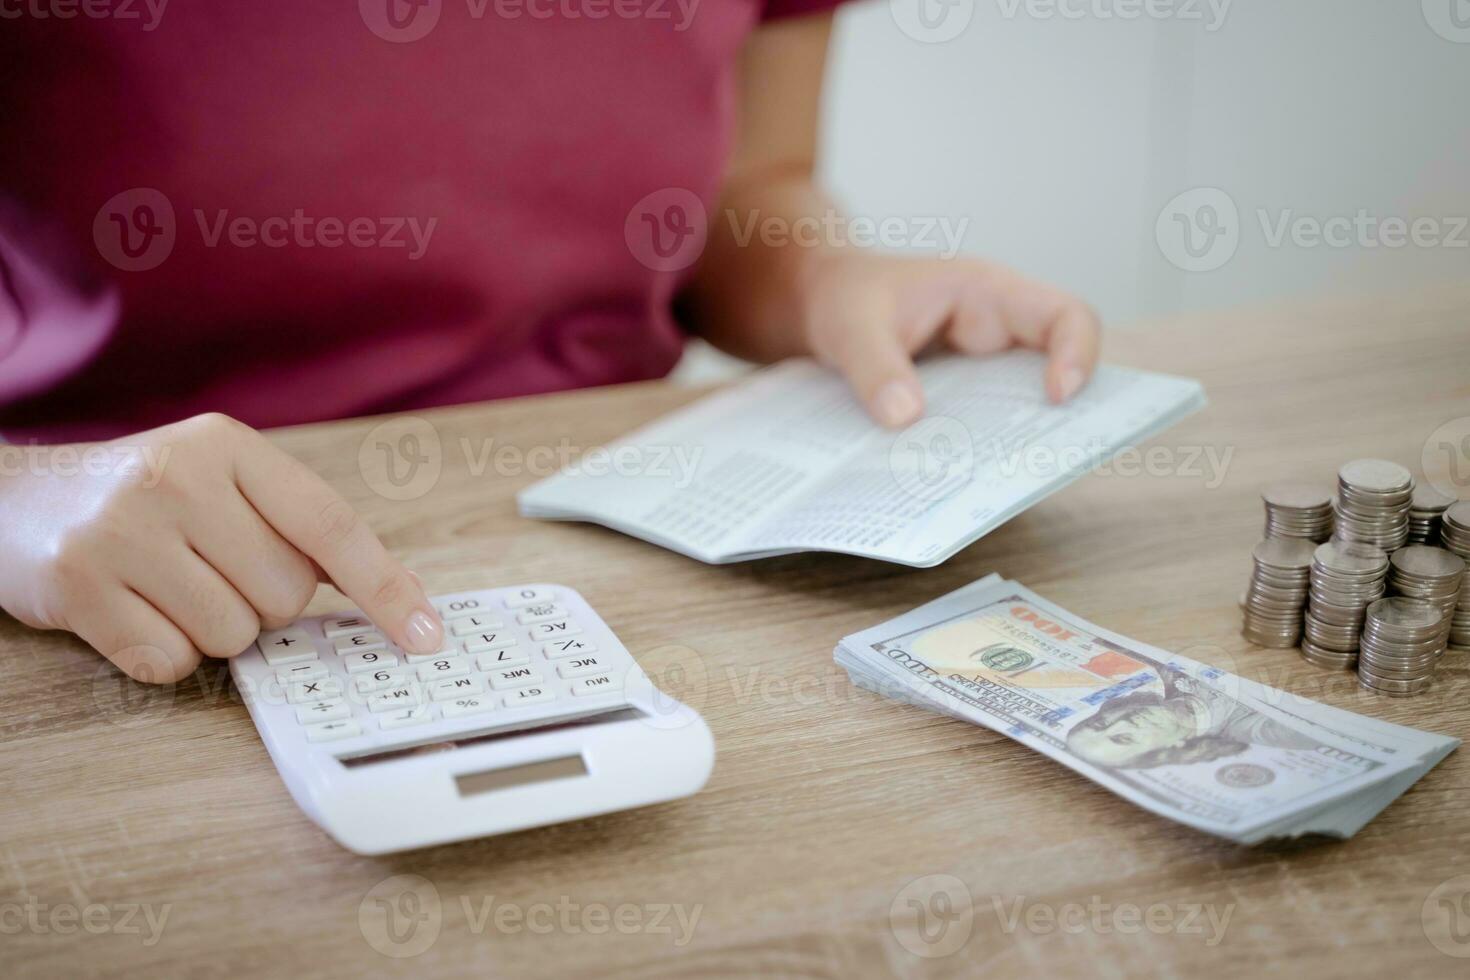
left=679, top=0, right=1470, bottom=379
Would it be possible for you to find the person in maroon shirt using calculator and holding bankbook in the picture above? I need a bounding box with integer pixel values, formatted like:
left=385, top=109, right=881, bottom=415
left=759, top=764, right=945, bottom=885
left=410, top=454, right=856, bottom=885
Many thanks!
left=0, top=0, right=1098, bottom=680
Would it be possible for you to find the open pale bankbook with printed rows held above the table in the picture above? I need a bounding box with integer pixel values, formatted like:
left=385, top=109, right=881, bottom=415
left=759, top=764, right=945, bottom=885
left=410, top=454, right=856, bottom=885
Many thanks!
left=519, top=351, right=1204, bottom=567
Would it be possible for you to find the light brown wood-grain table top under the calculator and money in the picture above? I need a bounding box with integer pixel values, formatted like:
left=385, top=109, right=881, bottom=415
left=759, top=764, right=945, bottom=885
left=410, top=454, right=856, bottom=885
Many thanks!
left=0, top=288, right=1470, bottom=979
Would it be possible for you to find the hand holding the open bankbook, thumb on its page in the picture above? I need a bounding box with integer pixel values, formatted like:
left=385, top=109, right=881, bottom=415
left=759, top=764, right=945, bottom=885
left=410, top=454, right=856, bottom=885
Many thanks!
left=803, top=250, right=1100, bottom=428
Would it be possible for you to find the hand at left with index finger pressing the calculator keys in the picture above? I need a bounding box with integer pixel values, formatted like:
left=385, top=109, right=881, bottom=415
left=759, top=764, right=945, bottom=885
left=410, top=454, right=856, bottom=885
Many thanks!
left=0, top=414, right=444, bottom=683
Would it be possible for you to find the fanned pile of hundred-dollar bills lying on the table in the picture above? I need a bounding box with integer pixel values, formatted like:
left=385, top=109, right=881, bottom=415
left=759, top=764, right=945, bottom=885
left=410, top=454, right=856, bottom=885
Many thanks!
left=835, top=574, right=1460, bottom=843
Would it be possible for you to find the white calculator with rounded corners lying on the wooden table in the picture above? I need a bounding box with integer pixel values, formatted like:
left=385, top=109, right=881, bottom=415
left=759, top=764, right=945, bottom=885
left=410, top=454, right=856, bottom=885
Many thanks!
left=231, top=585, right=714, bottom=854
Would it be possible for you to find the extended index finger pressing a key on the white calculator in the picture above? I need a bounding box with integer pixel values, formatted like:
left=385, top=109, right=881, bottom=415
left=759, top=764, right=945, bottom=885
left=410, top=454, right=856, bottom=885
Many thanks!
left=235, top=438, right=444, bottom=654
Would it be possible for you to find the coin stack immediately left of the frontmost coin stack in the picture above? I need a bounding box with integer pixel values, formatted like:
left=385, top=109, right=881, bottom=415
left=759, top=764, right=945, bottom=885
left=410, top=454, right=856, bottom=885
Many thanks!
left=1301, top=541, right=1388, bottom=670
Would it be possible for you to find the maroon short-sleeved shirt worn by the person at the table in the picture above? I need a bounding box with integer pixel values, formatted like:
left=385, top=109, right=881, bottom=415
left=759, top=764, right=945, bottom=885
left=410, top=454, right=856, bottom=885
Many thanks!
left=0, top=0, right=836, bottom=441
